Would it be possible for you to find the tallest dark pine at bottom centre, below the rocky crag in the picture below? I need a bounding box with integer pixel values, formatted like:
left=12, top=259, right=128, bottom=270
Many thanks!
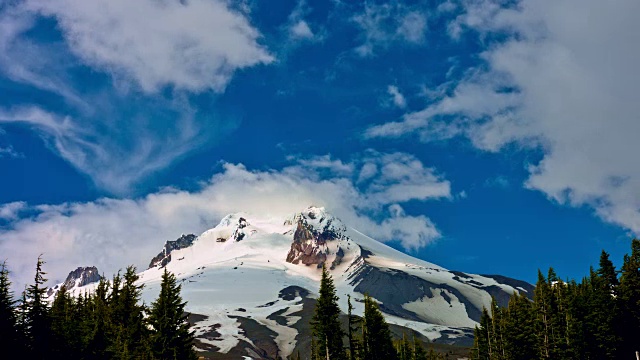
left=311, top=264, right=347, bottom=360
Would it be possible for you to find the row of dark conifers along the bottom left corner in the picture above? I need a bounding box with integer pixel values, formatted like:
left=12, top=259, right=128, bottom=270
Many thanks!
left=0, top=258, right=197, bottom=360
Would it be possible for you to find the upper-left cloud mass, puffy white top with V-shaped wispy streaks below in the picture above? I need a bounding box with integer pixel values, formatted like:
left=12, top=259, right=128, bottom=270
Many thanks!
left=0, top=0, right=274, bottom=194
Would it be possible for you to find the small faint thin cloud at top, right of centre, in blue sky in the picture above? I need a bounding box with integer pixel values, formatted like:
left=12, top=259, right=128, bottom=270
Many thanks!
left=352, top=3, right=427, bottom=56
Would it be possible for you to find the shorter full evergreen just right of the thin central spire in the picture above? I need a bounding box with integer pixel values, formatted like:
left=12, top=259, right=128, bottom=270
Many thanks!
left=362, top=295, right=398, bottom=360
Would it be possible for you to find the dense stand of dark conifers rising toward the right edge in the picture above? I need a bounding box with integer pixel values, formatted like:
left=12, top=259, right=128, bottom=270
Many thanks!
left=471, top=240, right=640, bottom=360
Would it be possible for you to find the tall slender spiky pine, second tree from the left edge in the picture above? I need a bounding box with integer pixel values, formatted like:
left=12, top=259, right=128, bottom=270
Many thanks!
left=25, top=256, right=51, bottom=359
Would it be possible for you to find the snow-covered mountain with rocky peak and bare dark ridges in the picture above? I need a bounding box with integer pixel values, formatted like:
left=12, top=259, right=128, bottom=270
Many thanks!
left=50, top=207, right=533, bottom=359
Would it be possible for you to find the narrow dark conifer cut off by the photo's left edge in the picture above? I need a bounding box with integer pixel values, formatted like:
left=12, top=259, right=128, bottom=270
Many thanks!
left=0, top=263, right=21, bottom=348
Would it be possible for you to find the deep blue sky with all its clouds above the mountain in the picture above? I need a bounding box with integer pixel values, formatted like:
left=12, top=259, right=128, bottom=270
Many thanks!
left=0, top=0, right=640, bottom=281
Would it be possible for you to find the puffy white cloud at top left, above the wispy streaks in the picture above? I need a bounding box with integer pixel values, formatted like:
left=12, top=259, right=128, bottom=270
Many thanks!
left=22, top=0, right=274, bottom=92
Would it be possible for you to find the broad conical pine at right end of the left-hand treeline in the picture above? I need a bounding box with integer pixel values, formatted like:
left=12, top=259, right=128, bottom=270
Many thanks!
left=148, top=267, right=197, bottom=360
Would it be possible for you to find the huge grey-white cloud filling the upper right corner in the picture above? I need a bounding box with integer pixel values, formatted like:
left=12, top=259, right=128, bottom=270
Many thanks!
left=367, top=0, right=640, bottom=235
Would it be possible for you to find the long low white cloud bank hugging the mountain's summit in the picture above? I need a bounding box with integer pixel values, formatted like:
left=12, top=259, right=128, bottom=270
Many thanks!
left=0, top=152, right=450, bottom=284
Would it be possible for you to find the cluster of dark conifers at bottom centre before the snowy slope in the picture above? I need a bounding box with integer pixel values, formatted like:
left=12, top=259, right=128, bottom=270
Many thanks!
left=298, top=267, right=447, bottom=360
